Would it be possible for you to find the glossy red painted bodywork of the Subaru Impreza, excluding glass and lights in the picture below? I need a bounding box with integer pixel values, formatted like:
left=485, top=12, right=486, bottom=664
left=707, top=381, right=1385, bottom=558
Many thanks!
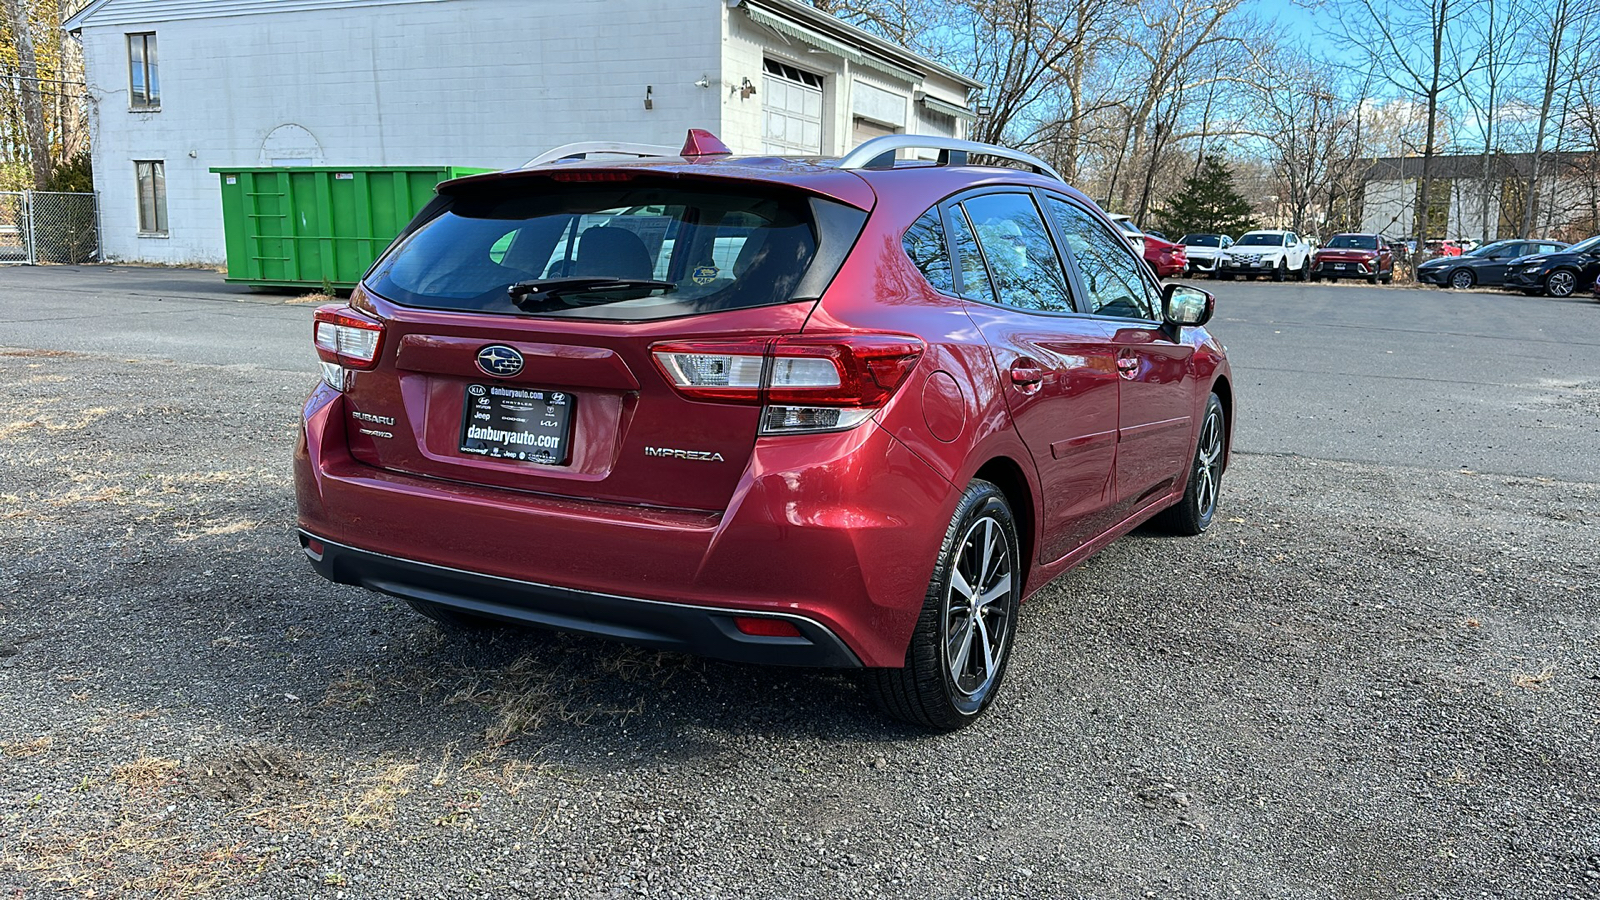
left=294, top=153, right=1234, bottom=666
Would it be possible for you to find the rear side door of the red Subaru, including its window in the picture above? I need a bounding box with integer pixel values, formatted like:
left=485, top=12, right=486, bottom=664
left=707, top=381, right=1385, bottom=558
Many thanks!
left=944, top=189, right=1117, bottom=562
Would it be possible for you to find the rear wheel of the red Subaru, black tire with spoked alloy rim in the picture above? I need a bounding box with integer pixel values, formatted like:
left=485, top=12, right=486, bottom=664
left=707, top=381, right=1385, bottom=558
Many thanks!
left=866, top=480, right=1022, bottom=732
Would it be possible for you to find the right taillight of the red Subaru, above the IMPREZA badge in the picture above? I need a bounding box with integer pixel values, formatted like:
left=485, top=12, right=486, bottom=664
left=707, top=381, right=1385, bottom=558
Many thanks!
left=651, top=335, right=923, bottom=434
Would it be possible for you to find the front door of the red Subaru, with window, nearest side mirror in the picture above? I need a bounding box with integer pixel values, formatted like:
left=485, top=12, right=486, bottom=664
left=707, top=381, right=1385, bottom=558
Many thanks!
left=1045, top=194, right=1195, bottom=516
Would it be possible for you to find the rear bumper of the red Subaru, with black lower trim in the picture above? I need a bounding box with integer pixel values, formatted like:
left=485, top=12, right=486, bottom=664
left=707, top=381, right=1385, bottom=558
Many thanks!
left=294, top=379, right=958, bottom=666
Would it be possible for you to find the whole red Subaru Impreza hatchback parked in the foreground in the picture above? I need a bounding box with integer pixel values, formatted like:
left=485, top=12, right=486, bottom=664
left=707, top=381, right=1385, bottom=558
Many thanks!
left=294, top=133, right=1234, bottom=729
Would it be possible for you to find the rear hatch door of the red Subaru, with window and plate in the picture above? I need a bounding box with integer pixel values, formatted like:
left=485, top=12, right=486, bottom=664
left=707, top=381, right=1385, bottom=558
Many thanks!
left=336, top=170, right=866, bottom=511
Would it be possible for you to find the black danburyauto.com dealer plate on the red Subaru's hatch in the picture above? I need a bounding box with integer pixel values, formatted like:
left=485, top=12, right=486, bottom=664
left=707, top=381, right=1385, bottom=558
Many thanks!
left=461, top=384, right=576, bottom=466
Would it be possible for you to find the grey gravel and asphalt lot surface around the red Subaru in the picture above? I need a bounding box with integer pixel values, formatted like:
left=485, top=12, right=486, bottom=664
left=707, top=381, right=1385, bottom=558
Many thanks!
left=0, top=272, right=1600, bottom=898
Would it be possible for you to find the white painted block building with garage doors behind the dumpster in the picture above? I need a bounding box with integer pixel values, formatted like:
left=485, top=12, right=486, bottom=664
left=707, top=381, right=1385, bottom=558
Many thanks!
left=66, top=0, right=982, bottom=263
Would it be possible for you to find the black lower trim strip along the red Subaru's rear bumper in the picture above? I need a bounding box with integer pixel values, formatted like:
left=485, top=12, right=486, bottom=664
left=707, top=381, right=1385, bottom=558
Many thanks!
left=301, top=532, right=861, bottom=668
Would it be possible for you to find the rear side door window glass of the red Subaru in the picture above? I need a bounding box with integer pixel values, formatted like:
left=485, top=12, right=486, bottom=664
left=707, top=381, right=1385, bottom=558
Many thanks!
left=962, top=194, right=1074, bottom=312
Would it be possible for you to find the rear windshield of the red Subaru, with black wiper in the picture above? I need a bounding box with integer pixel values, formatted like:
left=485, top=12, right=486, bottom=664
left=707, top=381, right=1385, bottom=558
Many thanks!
left=366, top=179, right=864, bottom=320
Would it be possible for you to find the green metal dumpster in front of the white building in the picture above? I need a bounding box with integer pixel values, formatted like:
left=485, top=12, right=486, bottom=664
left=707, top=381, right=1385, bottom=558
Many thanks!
left=211, top=165, right=491, bottom=288
